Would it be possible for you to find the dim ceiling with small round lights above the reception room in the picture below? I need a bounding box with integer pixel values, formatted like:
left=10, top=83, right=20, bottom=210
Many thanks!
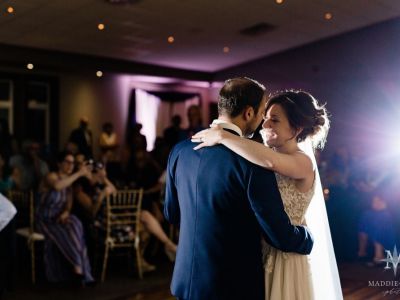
left=0, top=0, right=400, bottom=72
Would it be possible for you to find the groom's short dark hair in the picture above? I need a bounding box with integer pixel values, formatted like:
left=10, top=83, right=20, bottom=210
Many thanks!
left=218, top=77, right=265, bottom=118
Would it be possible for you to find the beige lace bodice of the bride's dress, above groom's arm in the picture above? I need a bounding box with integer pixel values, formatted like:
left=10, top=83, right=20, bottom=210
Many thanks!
left=275, top=174, right=315, bottom=225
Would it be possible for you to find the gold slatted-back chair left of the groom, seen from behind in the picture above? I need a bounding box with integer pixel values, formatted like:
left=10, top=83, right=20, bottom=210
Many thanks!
left=101, top=189, right=143, bottom=282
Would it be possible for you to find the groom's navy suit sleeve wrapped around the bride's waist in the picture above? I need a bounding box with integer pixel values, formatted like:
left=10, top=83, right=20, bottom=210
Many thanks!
left=247, top=166, right=314, bottom=254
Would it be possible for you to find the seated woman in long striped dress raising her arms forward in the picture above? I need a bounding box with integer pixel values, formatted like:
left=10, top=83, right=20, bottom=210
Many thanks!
left=37, top=152, right=94, bottom=284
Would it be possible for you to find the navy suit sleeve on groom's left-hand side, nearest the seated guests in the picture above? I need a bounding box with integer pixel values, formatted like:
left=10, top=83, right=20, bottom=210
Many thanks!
left=164, top=151, right=181, bottom=225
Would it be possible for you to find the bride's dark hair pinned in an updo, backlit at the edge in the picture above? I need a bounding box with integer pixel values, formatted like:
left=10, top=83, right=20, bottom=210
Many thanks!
left=265, top=90, right=329, bottom=149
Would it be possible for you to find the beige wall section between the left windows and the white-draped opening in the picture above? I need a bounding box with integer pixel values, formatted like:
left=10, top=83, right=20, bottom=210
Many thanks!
left=59, top=74, right=131, bottom=154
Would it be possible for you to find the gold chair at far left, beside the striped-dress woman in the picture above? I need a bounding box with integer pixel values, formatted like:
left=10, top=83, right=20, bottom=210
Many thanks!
left=8, top=190, right=44, bottom=283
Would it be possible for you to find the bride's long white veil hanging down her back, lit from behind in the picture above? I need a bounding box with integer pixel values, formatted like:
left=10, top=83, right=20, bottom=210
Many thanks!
left=302, top=140, right=343, bottom=300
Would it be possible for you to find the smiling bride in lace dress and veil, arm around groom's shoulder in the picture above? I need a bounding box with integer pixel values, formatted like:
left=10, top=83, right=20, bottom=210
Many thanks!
left=193, top=91, right=343, bottom=300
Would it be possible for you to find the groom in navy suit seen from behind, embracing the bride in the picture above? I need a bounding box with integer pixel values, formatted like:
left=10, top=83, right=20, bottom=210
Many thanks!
left=164, top=78, right=313, bottom=300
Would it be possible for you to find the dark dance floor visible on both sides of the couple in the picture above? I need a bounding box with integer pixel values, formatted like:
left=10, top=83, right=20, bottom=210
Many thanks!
left=4, top=262, right=400, bottom=300
